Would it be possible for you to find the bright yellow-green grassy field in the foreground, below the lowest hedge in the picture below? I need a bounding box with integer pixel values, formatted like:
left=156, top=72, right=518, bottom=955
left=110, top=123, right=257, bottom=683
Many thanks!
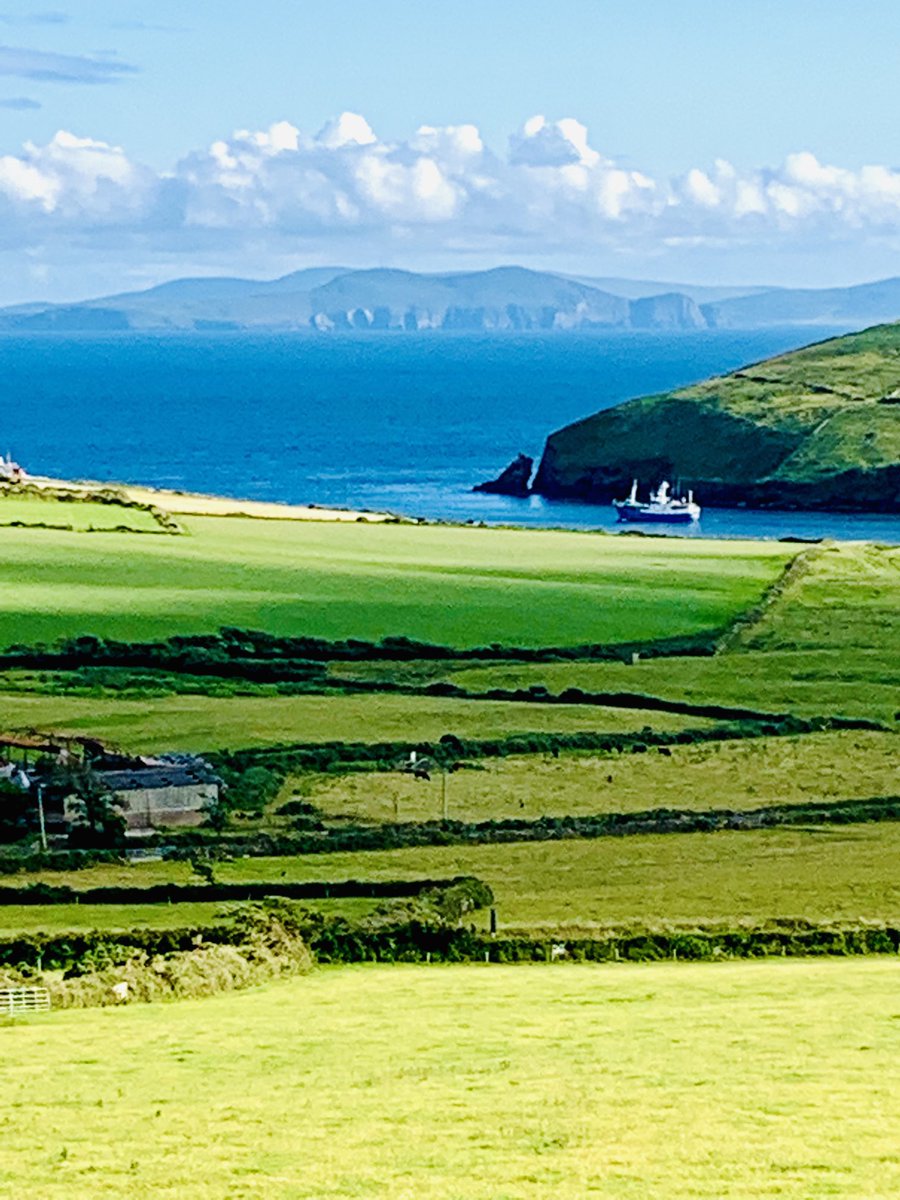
left=0, top=959, right=900, bottom=1200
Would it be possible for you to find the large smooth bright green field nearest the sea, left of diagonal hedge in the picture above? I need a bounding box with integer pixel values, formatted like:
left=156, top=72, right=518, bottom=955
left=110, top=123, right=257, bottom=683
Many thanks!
left=0, top=505, right=791, bottom=647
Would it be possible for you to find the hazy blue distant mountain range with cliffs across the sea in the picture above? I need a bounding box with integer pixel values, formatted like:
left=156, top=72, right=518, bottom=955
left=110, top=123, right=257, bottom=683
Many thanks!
left=0, top=266, right=900, bottom=332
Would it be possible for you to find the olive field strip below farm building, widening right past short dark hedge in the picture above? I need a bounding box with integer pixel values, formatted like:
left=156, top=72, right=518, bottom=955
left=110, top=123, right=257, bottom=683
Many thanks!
left=10, top=822, right=900, bottom=932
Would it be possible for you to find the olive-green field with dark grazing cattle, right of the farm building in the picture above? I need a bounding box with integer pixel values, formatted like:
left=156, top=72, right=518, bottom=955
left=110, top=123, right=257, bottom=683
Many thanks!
left=301, top=731, right=900, bottom=822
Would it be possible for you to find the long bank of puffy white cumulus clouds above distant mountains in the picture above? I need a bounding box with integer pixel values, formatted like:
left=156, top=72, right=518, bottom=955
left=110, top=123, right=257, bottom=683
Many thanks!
left=0, top=109, right=900, bottom=274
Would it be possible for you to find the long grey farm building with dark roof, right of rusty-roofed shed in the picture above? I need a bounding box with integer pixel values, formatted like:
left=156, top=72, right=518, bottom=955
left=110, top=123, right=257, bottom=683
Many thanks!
left=95, top=755, right=221, bottom=835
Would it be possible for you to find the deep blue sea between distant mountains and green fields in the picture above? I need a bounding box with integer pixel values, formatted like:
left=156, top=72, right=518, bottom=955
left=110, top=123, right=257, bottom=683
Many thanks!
left=0, top=326, right=900, bottom=542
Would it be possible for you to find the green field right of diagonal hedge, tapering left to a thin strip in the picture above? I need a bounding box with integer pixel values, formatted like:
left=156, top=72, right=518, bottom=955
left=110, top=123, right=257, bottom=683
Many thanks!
left=330, top=545, right=900, bottom=721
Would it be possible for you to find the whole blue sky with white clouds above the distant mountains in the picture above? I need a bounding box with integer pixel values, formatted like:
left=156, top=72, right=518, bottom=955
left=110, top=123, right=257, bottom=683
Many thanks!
left=0, top=0, right=900, bottom=304
